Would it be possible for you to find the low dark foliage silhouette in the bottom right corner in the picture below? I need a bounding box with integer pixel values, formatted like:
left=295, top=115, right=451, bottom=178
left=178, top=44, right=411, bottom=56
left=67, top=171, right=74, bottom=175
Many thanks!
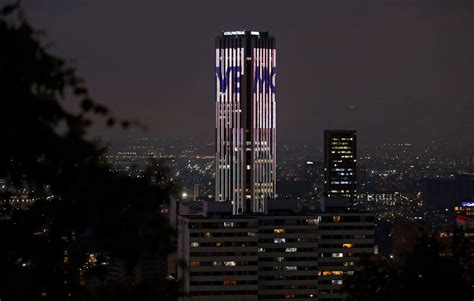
left=345, top=229, right=474, bottom=301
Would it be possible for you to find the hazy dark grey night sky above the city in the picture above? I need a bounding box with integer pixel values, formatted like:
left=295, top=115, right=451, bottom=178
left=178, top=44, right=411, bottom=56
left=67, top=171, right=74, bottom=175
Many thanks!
left=22, top=0, right=474, bottom=148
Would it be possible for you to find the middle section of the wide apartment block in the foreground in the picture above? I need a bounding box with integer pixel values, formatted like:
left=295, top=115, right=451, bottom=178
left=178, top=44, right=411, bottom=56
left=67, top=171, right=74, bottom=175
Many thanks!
left=258, top=216, right=319, bottom=300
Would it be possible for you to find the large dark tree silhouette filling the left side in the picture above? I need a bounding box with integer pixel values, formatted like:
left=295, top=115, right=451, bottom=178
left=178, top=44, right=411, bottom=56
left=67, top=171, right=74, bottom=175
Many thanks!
left=0, top=3, right=177, bottom=300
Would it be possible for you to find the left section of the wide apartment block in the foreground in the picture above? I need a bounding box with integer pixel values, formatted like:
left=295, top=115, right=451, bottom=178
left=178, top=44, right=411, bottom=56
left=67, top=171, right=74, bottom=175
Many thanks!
left=178, top=218, right=258, bottom=301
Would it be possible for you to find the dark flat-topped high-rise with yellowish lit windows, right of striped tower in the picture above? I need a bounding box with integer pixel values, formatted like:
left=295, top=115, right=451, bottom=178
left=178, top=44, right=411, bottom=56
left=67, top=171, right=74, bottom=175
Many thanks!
left=324, top=130, right=357, bottom=198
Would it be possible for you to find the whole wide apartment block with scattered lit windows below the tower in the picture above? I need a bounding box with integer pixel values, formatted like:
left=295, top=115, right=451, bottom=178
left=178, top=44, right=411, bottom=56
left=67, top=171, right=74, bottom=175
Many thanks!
left=178, top=202, right=375, bottom=301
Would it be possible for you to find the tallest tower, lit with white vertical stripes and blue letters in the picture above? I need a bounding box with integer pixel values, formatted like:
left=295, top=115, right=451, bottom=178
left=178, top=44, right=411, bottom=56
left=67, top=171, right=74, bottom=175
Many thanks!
left=216, top=31, right=276, bottom=214
